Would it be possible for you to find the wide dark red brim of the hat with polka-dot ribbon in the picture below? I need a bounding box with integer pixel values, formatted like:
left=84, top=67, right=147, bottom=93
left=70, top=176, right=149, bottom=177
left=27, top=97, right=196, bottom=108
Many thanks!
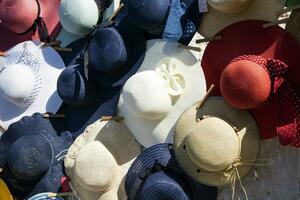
left=201, top=20, right=300, bottom=139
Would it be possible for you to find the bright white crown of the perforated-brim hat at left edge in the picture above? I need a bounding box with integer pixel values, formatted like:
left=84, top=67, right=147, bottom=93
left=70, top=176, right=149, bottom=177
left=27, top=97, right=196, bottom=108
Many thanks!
left=0, top=64, right=35, bottom=105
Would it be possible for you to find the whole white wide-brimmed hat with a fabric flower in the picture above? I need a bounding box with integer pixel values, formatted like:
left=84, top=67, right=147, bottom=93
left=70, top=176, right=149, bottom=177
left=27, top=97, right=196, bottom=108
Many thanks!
left=118, top=40, right=206, bottom=147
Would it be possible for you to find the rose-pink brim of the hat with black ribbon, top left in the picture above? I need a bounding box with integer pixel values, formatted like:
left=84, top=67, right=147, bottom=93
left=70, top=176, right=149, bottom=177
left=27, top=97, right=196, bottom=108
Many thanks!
left=0, top=0, right=61, bottom=51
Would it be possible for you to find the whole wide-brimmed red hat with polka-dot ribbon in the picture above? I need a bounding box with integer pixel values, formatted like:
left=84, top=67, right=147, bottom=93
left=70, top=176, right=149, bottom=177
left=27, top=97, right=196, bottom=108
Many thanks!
left=201, top=20, right=300, bottom=147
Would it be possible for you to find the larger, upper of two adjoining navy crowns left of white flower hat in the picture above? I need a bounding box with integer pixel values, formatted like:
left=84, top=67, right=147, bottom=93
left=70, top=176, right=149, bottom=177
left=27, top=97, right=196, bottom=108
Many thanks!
left=88, top=28, right=130, bottom=73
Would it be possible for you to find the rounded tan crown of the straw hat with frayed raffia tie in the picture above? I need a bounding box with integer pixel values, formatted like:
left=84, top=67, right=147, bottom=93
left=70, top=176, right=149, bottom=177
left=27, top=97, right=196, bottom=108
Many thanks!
left=184, top=117, right=240, bottom=172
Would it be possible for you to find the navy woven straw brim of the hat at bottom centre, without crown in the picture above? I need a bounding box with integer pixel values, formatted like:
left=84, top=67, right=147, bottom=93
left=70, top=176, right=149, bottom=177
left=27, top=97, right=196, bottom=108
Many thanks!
left=125, top=143, right=217, bottom=199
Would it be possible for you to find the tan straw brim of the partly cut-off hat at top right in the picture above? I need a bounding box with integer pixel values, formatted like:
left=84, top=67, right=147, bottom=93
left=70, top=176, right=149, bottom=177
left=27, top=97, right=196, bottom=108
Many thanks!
left=198, top=0, right=284, bottom=37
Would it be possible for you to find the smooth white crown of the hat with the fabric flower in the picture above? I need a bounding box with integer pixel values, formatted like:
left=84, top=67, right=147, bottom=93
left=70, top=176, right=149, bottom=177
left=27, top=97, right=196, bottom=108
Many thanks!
left=122, top=70, right=172, bottom=120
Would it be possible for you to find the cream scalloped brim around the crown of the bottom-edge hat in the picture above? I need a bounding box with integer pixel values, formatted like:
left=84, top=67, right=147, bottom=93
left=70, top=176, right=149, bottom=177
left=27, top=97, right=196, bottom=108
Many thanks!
left=65, top=120, right=140, bottom=200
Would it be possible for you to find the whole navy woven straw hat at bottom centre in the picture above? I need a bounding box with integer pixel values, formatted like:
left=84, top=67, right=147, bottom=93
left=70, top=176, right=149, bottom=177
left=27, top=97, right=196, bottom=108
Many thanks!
left=125, top=144, right=217, bottom=200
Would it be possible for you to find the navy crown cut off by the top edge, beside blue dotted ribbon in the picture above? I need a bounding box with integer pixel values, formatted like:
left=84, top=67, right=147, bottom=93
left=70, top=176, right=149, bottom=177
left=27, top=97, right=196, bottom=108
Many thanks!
left=124, top=0, right=170, bottom=32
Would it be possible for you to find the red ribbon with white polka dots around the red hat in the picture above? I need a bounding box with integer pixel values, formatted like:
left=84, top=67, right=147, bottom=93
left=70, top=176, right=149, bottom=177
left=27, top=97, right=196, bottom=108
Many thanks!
left=232, top=55, right=300, bottom=148
